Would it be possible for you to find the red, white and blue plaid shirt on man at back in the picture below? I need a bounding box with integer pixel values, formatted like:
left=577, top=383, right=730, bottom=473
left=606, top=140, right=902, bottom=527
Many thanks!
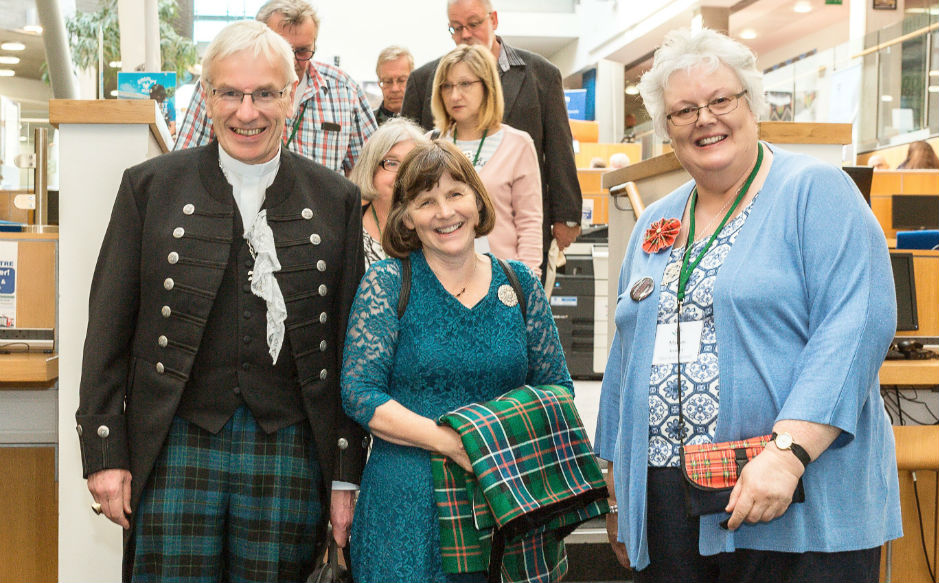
left=173, top=61, right=378, bottom=174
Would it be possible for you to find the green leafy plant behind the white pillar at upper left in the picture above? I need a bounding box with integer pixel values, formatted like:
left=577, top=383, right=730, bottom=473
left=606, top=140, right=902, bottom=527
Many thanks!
left=57, top=0, right=198, bottom=97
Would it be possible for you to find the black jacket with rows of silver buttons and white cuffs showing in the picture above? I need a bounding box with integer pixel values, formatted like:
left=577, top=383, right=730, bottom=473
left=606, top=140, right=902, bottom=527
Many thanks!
left=76, top=142, right=365, bottom=540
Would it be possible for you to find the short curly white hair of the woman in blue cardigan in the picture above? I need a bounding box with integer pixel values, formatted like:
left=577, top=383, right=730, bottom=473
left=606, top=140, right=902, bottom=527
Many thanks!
left=639, top=28, right=766, bottom=138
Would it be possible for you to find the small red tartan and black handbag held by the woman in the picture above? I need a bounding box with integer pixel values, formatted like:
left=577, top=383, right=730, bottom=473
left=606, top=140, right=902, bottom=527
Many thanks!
left=678, top=435, right=805, bottom=516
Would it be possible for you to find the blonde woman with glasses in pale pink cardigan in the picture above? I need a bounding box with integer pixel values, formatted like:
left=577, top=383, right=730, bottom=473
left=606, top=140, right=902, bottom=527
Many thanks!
left=431, top=45, right=544, bottom=275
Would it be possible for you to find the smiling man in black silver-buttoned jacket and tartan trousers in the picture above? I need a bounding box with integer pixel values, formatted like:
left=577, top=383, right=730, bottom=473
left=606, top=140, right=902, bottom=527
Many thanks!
left=76, top=21, right=365, bottom=582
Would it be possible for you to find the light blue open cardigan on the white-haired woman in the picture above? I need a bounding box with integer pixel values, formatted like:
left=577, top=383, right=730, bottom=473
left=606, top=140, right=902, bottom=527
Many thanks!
left=595, top=144, right=902, bottom=569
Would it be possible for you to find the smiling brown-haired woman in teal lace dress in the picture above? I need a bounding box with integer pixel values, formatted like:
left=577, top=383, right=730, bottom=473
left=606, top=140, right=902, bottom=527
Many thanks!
left=342, top=141, right=573, bottom=583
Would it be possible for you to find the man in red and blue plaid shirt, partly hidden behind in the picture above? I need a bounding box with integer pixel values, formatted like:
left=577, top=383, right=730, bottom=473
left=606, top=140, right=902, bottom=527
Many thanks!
left=174, top=0, right=378, bottom=175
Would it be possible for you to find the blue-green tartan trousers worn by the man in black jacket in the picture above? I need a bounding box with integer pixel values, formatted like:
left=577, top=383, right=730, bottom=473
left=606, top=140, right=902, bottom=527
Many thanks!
left=133, top=406, right=323, bottom=583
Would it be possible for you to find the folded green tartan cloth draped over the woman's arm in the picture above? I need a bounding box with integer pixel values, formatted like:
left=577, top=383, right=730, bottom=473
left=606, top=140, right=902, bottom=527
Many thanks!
left=431, top=386, right=609, bottom=583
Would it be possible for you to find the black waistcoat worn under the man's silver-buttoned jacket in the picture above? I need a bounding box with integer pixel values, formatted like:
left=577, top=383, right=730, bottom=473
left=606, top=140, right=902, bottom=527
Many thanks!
left=176, top=205, right=306, bottom=433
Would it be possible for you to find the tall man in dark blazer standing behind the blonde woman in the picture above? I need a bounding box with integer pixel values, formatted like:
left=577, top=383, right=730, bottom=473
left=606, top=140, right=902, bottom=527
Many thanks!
left=401, top=0, right=583, bottom=273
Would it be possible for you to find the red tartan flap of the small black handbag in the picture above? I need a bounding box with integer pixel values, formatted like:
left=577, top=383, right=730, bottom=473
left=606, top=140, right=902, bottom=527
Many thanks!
left=680, top=435, right=772, bottom=490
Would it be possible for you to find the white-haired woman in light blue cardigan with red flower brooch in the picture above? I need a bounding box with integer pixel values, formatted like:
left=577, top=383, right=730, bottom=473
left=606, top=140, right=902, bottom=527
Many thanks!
left=595, top=29, right=901, bottom=583
